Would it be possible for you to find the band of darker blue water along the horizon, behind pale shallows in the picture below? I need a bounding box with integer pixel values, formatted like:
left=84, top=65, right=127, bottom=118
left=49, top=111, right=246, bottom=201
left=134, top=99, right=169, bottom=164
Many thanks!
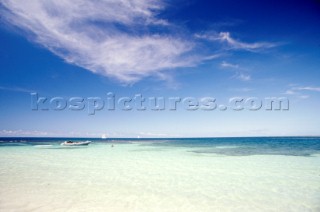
left=0, top=137, right=320, bottom=156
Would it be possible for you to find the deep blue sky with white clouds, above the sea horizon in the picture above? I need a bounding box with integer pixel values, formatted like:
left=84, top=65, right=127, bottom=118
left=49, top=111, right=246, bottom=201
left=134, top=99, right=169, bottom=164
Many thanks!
left=0, top=0, right=320, bottom=138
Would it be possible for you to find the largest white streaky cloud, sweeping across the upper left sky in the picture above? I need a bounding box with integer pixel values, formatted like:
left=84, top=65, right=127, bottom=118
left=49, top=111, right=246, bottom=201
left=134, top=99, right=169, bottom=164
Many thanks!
left=1, top=0, right=201, bottom=83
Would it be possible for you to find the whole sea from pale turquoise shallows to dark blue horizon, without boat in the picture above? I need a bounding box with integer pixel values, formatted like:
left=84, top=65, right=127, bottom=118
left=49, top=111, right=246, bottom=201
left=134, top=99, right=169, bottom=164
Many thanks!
left=0, top=137, right=320, bottom=211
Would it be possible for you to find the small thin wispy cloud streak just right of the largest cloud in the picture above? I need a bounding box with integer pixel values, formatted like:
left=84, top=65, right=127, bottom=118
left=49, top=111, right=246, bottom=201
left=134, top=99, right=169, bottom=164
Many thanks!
left=196, top=32, right=278, bottom=51
